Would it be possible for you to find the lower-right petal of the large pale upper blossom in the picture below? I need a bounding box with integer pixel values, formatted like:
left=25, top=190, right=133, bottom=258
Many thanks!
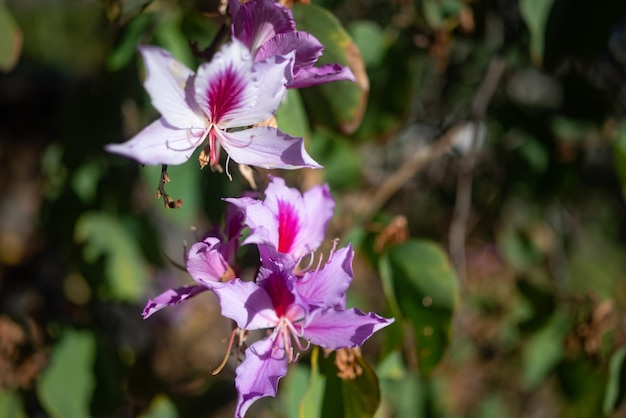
left=220, top=126, right=321, bottom=169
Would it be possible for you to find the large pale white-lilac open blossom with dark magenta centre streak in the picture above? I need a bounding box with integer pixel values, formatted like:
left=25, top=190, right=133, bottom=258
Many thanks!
left=106, top=40, right=320, bottom=170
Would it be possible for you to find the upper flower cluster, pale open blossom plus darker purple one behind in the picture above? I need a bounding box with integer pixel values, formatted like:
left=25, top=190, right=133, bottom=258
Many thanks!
left=106, top=0, right=354, bottom=170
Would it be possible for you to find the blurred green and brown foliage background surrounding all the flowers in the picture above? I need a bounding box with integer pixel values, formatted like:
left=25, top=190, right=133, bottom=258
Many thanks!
left=0, top=0, right=626, bottom=418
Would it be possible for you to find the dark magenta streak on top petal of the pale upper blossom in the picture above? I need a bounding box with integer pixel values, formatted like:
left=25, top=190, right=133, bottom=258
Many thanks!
left=207, top=62, right=246, bottom=125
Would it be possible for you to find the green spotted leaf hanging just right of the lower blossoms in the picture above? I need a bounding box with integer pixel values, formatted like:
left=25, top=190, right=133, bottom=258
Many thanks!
left=384, top=240, right=459, bottom=374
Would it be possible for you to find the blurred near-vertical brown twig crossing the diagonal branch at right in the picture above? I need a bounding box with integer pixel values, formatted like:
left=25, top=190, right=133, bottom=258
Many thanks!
left=448, top=57, right=505, bottom=283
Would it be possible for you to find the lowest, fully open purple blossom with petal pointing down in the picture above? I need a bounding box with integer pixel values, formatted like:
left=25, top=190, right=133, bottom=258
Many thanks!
left=213, top=248, right=394, bottom=417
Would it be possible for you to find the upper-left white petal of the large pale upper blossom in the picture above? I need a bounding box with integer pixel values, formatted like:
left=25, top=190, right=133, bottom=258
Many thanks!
left=139, top=46, right=204, bottom=129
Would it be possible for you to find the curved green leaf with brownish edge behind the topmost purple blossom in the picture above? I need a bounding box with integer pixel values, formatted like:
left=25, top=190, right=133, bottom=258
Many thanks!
left=293, top=3, right=369, bottom=134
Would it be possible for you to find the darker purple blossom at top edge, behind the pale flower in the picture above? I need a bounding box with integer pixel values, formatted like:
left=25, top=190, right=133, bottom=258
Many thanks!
left=228, top=0, right=355, bottom=88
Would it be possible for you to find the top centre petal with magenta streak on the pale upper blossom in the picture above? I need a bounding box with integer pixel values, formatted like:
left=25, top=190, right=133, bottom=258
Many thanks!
left=193, top=40, right=256, bottom=127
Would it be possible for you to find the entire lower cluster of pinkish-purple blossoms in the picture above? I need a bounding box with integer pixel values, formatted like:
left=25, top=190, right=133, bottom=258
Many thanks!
left=143, top=177, right=393, bottom=417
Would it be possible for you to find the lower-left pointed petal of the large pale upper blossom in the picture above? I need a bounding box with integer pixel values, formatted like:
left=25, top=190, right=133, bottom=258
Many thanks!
left=105, top=118, right=205, bottom=165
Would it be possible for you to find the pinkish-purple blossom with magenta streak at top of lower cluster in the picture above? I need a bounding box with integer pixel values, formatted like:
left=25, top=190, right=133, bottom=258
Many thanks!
left=225, top=177, right=335, bottom=262
